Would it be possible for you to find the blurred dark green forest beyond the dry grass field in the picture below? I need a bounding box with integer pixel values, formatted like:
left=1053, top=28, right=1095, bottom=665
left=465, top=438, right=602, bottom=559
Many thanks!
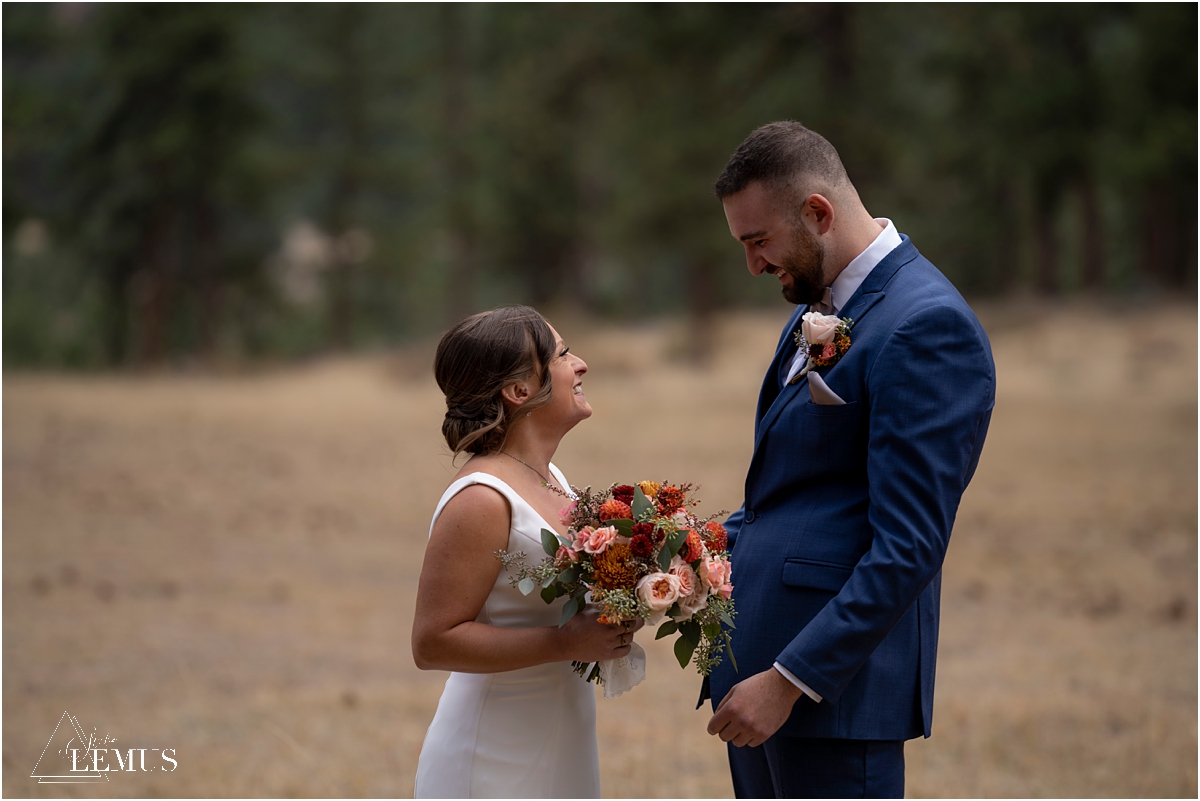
left=2, top=4, right=1198, bottom=368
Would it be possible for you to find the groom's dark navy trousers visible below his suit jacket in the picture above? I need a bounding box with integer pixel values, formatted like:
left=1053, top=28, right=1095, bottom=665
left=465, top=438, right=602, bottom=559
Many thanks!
left=728, top=734, right=904, bottom=799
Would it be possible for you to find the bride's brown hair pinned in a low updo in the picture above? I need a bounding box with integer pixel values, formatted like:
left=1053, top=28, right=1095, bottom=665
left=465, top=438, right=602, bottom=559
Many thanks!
left=433, top=306, right=557, bottom=456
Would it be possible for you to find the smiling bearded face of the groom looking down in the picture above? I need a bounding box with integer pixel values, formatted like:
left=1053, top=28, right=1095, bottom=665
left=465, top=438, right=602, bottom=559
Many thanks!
left=724, top=181, right=827, bottom=303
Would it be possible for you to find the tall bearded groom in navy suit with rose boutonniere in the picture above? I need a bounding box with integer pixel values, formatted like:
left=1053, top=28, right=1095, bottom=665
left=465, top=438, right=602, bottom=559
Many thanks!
left=701, top=121, right=996, bottom=797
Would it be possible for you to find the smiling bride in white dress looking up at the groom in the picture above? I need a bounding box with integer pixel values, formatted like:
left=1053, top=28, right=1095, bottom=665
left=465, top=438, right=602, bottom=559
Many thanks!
left=413, top=306, right=642, bottom=799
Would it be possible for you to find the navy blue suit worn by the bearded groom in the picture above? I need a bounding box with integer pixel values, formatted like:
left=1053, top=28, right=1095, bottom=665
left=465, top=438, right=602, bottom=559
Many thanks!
left=710, top=237, right=996, bottom=796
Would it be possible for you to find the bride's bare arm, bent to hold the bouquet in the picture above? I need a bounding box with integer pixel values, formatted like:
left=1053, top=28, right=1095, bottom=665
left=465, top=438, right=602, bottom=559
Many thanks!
left=413, top=484, right=632, bottom=673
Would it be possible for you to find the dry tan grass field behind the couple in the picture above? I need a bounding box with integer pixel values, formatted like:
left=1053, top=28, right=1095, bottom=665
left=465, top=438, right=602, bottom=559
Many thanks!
left=2, top=302, right=1196, bottom=797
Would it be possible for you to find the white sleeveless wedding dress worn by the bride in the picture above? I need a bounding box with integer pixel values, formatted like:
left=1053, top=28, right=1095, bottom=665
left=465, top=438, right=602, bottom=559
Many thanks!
left=413, top=464, right=600, bottom=799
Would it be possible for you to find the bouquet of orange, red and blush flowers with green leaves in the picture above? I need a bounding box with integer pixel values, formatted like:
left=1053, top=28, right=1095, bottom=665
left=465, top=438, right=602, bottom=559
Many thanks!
left=497, top=481, right=737, bottom=695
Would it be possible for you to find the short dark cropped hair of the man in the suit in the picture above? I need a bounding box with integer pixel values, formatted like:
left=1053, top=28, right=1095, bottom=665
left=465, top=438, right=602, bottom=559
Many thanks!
left=713, top=120, right=850, bottom=200
